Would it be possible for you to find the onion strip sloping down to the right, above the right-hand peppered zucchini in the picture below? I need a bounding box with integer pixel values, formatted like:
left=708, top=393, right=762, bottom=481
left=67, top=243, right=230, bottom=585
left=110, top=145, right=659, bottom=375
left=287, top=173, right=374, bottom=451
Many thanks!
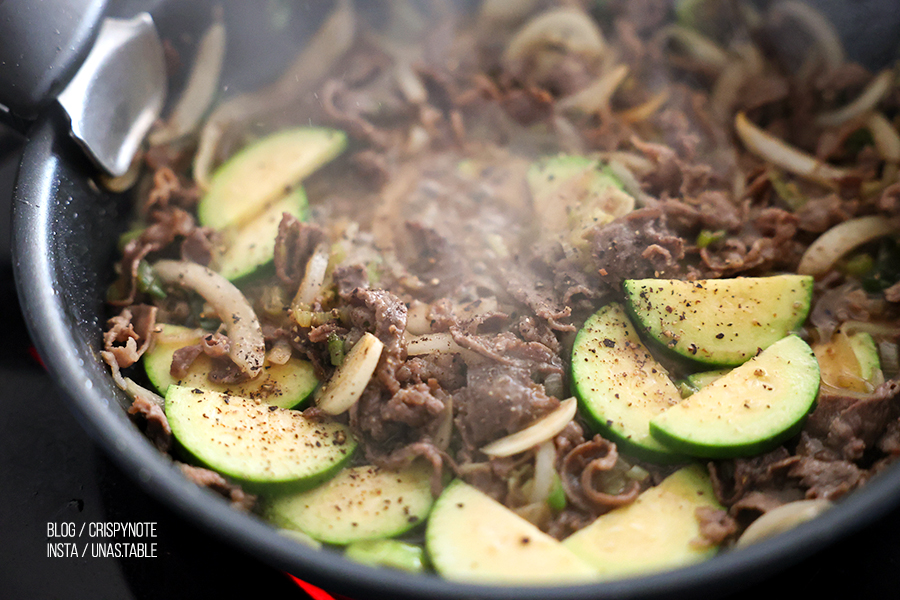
left=734, top=112, right=848, bottom=185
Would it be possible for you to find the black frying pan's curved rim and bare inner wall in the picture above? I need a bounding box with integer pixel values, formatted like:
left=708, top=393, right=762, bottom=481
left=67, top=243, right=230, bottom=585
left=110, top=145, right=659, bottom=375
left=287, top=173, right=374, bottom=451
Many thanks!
left=7, top=1, right=900, bottom=600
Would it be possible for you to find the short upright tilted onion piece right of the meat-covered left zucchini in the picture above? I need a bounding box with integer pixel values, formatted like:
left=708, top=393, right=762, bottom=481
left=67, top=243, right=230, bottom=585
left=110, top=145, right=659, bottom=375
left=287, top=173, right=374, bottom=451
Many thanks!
left=316, top=332, right=384, bottom=415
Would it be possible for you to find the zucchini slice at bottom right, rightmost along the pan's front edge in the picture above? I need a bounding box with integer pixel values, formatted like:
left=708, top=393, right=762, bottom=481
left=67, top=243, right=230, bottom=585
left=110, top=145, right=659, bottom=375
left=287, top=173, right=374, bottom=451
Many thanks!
left=563, top=465, right=721, bottom=579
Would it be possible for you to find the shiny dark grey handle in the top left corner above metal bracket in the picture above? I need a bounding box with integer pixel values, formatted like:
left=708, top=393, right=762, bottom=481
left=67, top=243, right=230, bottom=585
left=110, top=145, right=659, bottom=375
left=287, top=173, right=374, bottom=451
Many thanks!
left=0, top=0, right=109, bottom=121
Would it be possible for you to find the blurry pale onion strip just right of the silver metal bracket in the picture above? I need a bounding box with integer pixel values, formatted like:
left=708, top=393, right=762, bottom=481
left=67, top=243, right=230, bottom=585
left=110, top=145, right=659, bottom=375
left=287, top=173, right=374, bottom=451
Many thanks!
left=148, top=21, right=225, bottom=146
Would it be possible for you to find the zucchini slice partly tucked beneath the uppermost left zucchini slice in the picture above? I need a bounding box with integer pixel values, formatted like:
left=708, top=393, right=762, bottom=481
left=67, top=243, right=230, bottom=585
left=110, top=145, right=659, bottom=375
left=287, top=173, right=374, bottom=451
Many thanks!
left=215, top=187, right=307, bottom=281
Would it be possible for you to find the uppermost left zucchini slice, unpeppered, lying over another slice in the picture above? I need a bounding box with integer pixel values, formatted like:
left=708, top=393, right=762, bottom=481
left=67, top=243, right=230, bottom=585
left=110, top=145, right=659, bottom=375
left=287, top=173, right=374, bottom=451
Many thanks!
left=197, top=127, right=347, bottom=229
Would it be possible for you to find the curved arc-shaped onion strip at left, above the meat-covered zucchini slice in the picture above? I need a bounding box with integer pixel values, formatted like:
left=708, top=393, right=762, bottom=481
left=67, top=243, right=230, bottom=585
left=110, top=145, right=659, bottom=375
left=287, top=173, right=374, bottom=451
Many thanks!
left=153, top=260, right=266, bottom=377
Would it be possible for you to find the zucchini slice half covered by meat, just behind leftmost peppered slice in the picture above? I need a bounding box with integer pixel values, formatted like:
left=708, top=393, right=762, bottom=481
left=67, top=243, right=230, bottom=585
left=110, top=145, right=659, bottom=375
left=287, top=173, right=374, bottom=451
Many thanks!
left=143, top=324, right=319, bottom=408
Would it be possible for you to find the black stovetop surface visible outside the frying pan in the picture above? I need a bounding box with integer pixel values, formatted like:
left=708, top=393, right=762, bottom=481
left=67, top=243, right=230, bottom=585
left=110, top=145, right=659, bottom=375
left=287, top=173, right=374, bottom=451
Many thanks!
left=0, top=124, right=900, bottom=600
